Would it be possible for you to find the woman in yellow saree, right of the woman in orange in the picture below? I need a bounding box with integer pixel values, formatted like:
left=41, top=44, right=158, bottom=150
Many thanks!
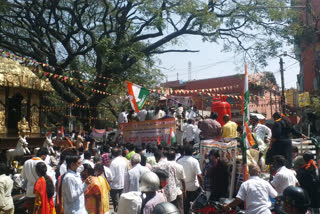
left=94, top=163, right=111, bottom=214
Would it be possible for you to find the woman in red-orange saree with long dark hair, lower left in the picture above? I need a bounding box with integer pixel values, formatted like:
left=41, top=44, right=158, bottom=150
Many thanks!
left=33, top=162, right=56, bottom=214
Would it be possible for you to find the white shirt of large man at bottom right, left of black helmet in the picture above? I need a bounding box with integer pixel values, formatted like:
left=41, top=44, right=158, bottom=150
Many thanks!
left=236, top=176, right=277, bottom=214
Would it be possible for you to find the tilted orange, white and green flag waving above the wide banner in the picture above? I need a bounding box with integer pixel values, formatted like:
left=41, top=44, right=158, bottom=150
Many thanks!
left=126, top=81, right=149, bottom=113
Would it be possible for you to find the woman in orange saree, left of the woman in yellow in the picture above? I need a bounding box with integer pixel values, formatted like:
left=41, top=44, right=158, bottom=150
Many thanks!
left=81, top=164, right=103, bottom=214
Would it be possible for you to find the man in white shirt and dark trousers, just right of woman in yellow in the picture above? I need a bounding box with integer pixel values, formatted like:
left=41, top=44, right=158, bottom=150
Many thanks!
left=110, top=148, right=129, bottom=211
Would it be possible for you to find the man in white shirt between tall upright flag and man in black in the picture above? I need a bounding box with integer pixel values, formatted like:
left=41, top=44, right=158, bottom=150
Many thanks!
left=250, top=116, right=272, bottom=144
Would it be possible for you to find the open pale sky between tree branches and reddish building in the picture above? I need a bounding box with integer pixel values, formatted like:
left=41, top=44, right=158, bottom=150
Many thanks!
left=158, top=36, right=300, bottom=89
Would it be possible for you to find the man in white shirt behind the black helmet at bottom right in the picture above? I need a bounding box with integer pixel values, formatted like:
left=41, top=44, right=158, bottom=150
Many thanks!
left=271, top=155, right=298, bottom=196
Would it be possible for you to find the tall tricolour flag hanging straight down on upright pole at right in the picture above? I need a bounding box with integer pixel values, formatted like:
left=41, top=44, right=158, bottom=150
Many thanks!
left=241, top=64, right=255, bottom=147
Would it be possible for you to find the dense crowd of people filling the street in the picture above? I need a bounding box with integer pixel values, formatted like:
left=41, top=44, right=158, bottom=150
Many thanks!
left=0, top=109, right=320, bottom=214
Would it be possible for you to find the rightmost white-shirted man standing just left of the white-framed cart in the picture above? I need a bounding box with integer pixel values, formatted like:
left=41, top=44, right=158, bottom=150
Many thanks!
left=178, top=145, right=202, bottom=213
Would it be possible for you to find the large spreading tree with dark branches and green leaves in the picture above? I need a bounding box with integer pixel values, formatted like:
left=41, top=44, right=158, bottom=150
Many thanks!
left=0, top=0, right=294, bottom=124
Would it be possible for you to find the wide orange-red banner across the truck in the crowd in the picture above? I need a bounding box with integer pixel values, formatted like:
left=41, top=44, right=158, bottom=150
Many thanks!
left=119, top=118, right=175, bottom=144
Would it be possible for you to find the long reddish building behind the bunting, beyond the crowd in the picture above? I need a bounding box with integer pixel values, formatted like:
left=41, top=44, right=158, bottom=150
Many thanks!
left=162, top=73, right=280, bottom=122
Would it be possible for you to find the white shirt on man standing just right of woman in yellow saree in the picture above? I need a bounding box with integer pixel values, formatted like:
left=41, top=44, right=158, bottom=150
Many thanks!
left=110, top=156, right=129, bottom=189
